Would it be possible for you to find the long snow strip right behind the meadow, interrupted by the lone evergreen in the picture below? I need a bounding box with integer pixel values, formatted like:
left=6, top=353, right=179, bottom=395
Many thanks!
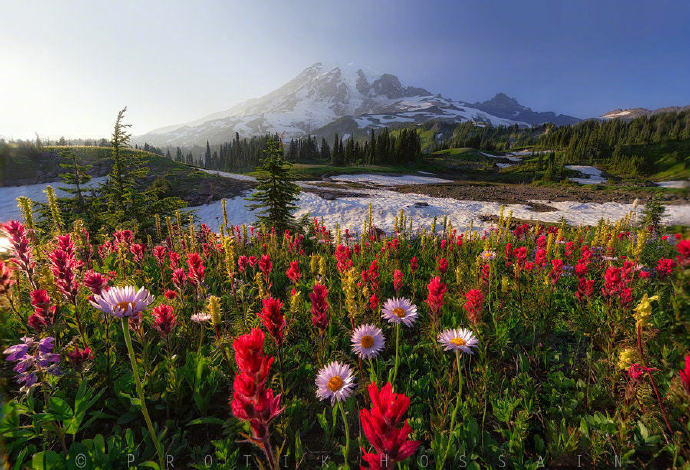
left=185, top=185, right=690, bottom=232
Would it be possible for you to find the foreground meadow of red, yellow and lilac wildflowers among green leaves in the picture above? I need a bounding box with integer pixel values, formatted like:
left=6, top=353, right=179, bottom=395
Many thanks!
left=0, top=207, right=690, bottom=469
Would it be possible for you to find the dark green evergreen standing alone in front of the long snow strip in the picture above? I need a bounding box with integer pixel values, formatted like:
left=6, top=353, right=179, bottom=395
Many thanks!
left=247, top=139, right=300, bottom=231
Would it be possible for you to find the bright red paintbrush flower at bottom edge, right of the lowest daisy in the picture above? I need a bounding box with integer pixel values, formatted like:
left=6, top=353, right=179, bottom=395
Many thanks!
left=359, top=382, right=420, bottom=469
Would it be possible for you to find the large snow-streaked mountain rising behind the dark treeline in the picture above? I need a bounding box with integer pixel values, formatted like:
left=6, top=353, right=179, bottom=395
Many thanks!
left=134, top=63, right=544, bottom=146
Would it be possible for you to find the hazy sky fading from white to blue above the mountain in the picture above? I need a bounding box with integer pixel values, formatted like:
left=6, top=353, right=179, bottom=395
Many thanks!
left=0, top=0, right=690, bottom=139
